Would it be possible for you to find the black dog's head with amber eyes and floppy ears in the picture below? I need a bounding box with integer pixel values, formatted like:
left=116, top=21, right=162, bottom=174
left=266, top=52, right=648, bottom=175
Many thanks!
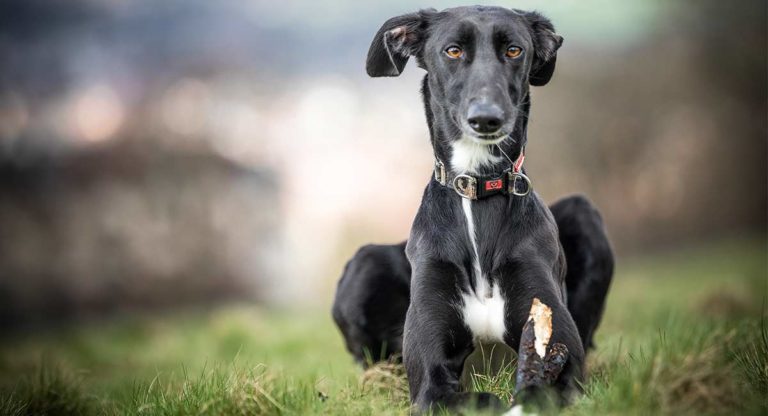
left=366, top=6, right=563, bottom=145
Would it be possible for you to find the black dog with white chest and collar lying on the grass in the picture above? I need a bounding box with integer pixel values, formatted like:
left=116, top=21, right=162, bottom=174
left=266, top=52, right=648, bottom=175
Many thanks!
left=334, top=7, right=613, bottom=409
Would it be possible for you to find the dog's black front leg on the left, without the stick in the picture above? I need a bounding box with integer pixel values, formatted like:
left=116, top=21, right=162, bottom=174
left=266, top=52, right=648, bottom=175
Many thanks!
left=403, top=262, right=503, bottom=411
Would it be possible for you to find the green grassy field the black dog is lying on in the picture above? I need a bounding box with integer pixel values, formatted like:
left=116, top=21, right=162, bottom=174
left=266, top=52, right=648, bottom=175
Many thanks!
left=0, top=239, right=768, bottom=415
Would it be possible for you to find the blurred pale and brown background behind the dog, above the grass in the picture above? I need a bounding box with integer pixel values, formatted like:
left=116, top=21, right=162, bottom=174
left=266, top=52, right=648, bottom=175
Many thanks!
left=0, top=0, right=768, bottom=329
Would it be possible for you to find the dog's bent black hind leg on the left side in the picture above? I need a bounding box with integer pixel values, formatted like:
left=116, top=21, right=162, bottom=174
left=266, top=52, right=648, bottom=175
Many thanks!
left=332, top=242, right=411, bottom=366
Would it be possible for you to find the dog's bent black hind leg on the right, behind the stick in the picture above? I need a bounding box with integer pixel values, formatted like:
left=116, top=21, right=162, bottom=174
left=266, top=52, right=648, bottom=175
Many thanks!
left=550, top=195, right=614, bottom=351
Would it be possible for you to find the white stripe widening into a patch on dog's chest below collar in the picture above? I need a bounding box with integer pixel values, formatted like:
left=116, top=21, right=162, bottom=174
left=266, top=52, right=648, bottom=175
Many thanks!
left=461, top=199, right=506, bottom=342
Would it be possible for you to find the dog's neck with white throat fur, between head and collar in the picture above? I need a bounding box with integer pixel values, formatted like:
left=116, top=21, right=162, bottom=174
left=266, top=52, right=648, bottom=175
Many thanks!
left=421, top=76, right=530, bottom=175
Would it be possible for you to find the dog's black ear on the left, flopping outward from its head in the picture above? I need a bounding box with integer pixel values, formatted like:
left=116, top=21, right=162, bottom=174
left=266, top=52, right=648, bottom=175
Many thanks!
left=365, top=13, right=424, bottom=77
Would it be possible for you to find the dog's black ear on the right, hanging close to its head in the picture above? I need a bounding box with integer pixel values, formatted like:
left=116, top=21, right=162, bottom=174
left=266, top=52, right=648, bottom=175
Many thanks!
left=525, top=12, right=563, bottom=87
